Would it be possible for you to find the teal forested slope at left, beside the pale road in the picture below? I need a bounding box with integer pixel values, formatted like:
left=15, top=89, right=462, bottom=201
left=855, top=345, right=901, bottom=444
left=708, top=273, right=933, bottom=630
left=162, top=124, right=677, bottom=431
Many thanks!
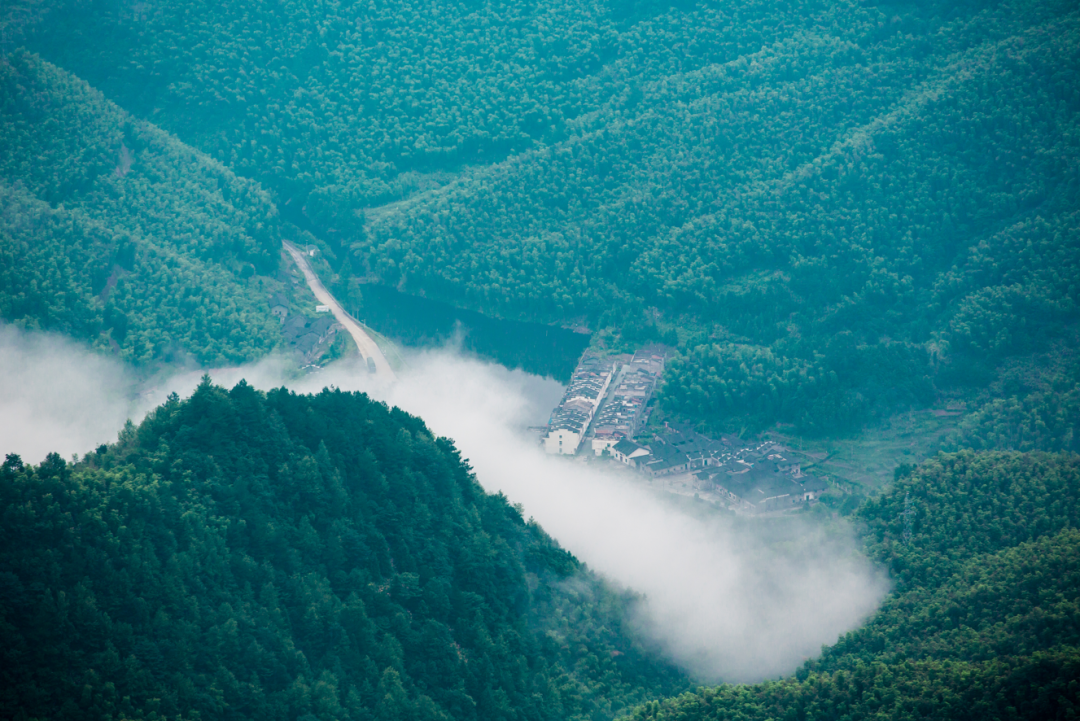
left=0, top=53, right=280, bottom=364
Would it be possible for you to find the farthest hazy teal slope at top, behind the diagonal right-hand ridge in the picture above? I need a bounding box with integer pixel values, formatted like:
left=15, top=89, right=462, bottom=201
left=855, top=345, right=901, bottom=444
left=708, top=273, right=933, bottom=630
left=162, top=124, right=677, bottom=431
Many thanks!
left=13, top=0, right=832, bottom=207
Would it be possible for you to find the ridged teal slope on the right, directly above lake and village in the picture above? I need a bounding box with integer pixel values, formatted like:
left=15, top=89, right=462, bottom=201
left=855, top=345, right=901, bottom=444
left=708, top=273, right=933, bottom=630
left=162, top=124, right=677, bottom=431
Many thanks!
left=365, top=3, right=1080, bottom=433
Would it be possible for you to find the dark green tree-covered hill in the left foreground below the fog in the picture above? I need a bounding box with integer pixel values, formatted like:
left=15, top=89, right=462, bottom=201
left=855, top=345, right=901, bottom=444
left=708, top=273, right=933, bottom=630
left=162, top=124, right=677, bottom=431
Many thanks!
left=0, top=379, right=685, bottom=721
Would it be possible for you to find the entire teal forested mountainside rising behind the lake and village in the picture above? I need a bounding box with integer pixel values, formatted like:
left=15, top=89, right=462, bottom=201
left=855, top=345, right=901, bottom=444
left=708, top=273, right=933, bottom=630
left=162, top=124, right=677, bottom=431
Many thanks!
left=8, top=0, right=1080, bottom=433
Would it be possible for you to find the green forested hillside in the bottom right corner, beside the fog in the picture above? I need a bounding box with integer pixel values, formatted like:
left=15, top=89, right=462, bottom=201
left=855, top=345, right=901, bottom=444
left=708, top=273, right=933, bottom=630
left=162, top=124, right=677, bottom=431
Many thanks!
left=617, top=451, right=1080, bottom=721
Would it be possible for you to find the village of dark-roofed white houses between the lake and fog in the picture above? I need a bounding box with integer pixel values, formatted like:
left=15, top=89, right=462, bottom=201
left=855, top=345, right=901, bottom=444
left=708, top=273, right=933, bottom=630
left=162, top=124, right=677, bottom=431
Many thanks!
left=541, top=345, right=828, bottom=515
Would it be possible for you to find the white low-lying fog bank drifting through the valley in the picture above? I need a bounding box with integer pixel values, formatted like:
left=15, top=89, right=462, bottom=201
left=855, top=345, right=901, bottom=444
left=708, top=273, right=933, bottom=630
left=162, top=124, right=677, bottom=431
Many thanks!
left=0, top=328, right=888, bottom=681
